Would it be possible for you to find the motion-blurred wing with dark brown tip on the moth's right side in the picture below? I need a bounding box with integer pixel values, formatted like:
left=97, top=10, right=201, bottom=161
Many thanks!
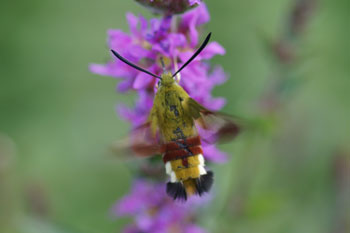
left=187, top=98, right=240, bottom=144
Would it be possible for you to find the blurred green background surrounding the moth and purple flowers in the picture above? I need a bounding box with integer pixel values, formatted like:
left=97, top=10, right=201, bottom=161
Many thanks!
left=0, top=0, right=350, bottom=233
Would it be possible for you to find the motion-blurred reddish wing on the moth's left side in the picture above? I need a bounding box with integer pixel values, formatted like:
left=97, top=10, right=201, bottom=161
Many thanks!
left=112, top=121, right=160, bottom=157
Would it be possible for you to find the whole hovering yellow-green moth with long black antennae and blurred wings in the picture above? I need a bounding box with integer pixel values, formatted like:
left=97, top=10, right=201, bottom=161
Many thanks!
left=111, top=33, right=240, bottom=200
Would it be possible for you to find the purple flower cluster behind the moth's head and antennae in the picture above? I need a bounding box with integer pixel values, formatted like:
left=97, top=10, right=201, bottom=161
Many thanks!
left=90, top=1, right=226, bottom=162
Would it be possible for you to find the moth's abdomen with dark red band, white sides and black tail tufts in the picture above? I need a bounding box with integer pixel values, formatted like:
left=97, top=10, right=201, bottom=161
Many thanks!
left=162, top=136, right=213, bottom=200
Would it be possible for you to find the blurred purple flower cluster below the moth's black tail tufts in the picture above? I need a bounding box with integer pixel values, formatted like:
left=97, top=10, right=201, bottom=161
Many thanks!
left=112, top=180, right=210, bottom=233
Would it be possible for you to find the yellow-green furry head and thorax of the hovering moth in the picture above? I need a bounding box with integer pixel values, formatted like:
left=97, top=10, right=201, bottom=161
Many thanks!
left=151, top=73, right=196, bottom=142
